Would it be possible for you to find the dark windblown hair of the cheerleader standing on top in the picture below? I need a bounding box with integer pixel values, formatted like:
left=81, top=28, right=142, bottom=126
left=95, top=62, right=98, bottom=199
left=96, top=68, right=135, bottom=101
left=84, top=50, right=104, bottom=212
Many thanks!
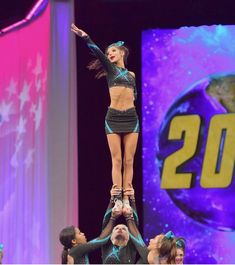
left=87, top=43, right=129, bottom=79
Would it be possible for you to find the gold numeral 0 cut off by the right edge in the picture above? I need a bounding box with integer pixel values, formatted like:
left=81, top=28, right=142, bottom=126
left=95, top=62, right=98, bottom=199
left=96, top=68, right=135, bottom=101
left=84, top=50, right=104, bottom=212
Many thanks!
left=201, top=114, right=235, bottom=188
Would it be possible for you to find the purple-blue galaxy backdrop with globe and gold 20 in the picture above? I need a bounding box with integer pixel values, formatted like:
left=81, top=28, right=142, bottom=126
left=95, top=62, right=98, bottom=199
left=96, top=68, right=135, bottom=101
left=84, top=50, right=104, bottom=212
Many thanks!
left=142, top=25, right=235, bottom=263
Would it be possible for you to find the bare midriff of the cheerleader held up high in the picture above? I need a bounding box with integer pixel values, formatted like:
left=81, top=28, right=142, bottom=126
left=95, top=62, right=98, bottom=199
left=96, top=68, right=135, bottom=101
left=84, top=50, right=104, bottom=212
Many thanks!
left=109, top=86, right=135, bottom=110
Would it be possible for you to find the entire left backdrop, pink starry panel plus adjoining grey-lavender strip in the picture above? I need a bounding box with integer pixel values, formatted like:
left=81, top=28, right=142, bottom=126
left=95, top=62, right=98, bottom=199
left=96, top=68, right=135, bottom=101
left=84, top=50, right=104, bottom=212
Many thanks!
left=0, top=0, right=78, bottom=264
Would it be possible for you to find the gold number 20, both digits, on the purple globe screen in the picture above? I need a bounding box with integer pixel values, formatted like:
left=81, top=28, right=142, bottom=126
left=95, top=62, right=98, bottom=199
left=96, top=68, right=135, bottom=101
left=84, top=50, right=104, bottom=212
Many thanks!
left=161, top=113, right=235, bottom=189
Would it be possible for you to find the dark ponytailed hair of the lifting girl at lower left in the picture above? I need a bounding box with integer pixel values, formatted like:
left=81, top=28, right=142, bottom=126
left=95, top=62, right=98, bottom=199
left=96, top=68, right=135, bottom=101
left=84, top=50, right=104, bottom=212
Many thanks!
left=60, top=225, right=75, bottom=264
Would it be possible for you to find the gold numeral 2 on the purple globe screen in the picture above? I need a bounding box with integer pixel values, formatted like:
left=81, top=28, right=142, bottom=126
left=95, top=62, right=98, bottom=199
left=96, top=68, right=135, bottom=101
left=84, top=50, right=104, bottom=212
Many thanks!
left=161, top=115, right=201, bottom=189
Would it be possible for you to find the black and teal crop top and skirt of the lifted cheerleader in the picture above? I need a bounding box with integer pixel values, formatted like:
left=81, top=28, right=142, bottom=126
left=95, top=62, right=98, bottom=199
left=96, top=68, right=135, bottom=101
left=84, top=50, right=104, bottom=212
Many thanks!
left=83, top=36, right=139, bottom=134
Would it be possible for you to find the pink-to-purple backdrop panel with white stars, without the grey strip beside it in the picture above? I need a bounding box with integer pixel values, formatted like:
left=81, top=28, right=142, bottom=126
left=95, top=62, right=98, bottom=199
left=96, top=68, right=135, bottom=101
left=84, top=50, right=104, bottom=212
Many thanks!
left=0, top=5, right=50, bottom=263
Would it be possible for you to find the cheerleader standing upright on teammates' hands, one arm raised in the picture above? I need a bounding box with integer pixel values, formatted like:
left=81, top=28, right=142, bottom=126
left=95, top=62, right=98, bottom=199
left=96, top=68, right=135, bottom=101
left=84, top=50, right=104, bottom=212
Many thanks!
left=71, top=24, right=139, bottom=208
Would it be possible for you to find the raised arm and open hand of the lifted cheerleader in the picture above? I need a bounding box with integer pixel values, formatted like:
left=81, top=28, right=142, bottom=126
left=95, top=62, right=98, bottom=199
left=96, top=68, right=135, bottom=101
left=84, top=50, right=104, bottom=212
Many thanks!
left=71, top=24, right=114, bottom=73
